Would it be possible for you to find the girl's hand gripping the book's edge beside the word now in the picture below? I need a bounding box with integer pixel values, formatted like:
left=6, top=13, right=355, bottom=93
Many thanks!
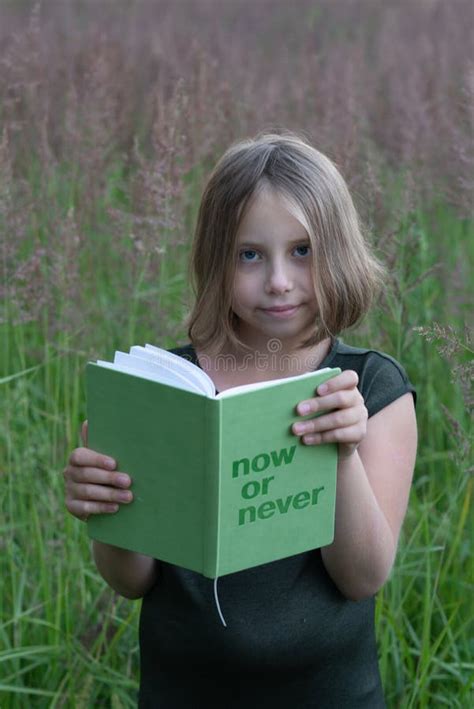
left=292, top=369, right=368, bottom=457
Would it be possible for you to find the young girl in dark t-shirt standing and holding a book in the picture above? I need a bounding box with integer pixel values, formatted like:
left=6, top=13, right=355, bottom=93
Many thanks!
left=64, top=134, right=417, bottom=709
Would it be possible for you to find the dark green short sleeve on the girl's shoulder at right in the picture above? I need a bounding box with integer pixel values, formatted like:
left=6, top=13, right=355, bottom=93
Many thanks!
left=359, top=352, right=416, bottom=417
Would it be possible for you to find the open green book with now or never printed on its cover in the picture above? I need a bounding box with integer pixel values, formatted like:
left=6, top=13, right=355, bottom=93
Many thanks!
left=86, top=345, right=340, bottom=579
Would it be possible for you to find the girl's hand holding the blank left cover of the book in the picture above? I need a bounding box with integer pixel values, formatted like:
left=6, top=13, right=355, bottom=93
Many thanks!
left=63, top=421, right=133, bottom=522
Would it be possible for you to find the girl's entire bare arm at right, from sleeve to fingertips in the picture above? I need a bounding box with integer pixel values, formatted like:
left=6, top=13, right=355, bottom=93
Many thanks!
left=293, top=371, right=417, bottom=600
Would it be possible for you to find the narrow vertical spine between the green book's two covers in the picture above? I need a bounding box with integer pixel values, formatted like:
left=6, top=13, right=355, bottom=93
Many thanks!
left=203, top=399, right=222, bottom=579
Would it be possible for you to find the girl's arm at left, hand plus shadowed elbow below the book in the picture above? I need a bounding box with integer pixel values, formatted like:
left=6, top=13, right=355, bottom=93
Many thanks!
left=63, top=422, right=159, bottom=598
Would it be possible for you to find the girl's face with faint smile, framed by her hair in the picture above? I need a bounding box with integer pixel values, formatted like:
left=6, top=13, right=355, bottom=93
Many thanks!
left=232, top=188, right=317, bottom=351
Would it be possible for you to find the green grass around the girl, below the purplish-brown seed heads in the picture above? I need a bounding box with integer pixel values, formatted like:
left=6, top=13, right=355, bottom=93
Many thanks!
left=0, top=163, right=474, bottom=709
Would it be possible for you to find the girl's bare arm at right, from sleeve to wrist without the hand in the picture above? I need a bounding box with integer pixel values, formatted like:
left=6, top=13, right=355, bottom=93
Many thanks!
left=321, top=394, right=417, bottom=600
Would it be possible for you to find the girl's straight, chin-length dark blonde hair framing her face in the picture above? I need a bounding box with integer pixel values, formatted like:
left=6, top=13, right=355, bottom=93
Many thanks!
left=187, top=133, right=384, bottom=354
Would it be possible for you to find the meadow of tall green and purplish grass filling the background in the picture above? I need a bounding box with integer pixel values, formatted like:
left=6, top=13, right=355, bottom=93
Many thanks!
left=0, top=0, right=474, bottom=709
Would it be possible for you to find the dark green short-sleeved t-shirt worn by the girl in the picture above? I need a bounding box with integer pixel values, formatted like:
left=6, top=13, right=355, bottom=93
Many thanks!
left=139, top=340, right=415, bottom=709
